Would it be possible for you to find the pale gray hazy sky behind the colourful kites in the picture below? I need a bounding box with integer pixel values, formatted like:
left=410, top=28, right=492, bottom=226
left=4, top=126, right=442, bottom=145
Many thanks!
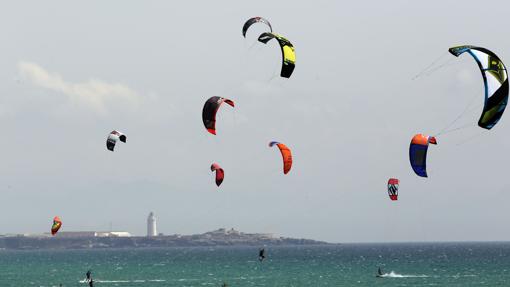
left=0, top=0, right=510, bottom=242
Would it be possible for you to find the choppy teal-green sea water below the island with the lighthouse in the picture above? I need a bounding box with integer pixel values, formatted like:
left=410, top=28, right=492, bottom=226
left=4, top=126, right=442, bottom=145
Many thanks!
left=0, top=243, right=510, bottom=287
